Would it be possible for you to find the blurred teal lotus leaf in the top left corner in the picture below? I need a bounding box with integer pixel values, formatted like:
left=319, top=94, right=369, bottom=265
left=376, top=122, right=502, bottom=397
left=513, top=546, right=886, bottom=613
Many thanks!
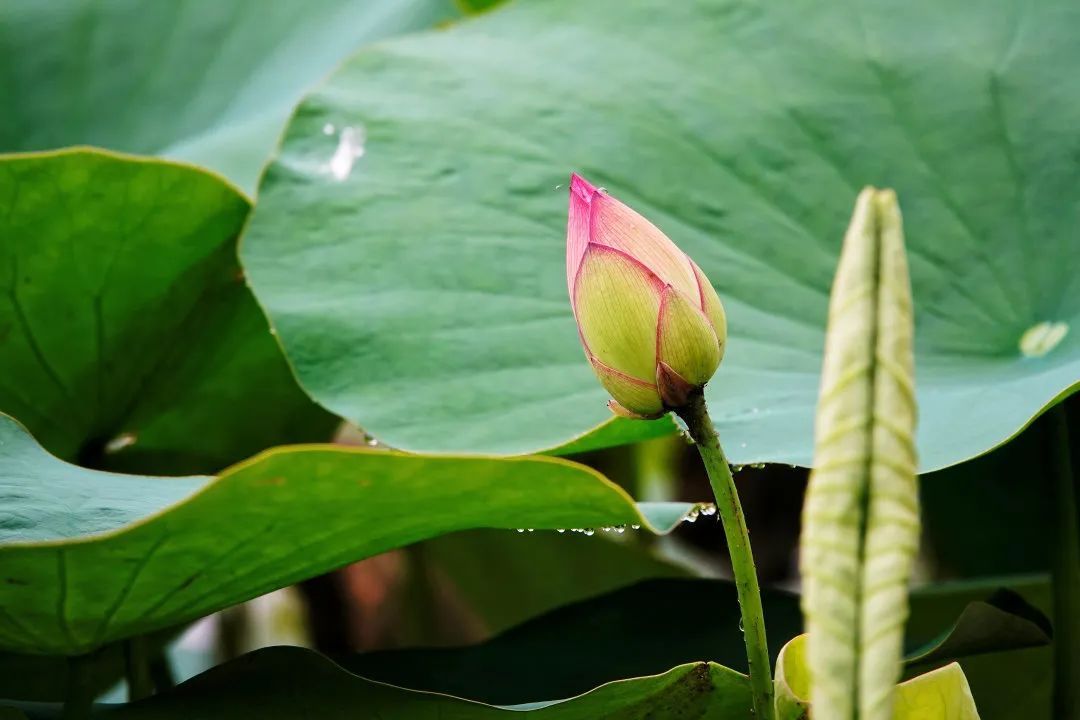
left=0, top=0, right=457, bottom=194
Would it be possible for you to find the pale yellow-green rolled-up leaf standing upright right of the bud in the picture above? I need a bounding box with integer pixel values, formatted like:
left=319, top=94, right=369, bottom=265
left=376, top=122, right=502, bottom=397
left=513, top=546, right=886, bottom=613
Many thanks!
left=799, top=188, right=919, bottom=720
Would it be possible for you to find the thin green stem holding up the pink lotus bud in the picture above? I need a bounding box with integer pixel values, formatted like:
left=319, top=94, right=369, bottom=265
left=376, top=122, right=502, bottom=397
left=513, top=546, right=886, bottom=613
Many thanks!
left=676, top=392, right=774, bottom=720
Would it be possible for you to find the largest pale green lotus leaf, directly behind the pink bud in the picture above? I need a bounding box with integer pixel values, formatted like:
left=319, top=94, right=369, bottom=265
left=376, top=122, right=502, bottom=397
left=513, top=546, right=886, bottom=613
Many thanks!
left=242, top=0, right=1080, bottom=468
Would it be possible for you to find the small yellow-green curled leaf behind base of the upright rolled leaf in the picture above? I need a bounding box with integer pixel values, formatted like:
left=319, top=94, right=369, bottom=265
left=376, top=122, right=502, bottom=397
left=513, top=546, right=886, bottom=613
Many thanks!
left=777, top=635, right=980, bottom=720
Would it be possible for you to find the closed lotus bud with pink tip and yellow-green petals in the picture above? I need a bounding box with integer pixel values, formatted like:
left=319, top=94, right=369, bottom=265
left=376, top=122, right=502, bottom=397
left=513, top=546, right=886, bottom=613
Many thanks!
left=566, top=175, right=727, bottom=418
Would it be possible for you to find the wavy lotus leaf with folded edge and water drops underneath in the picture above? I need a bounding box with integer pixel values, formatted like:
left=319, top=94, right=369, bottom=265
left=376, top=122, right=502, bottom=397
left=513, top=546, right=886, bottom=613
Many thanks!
left=0, top=416, right=691, bottom=654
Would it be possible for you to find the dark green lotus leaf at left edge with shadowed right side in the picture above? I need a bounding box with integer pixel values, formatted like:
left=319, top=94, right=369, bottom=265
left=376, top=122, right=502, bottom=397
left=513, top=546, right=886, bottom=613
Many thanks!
left=0, top=149, right=334, bottom=474
